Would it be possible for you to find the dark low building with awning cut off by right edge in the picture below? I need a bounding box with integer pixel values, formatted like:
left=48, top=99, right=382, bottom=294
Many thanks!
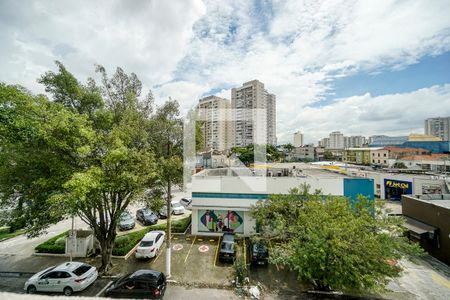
left=402, top=194, right=450, bottom=265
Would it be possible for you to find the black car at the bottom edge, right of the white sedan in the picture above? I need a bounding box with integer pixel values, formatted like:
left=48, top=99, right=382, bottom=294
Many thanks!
left=105, top=270, right=167, bottom=299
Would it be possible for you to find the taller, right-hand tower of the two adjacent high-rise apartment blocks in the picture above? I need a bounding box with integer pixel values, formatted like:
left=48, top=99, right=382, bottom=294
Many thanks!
left=231, top=80, right=276, bottom=147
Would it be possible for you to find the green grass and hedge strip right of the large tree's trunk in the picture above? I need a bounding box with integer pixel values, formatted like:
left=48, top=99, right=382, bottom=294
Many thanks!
left=112, top=216, right=191, bottom=256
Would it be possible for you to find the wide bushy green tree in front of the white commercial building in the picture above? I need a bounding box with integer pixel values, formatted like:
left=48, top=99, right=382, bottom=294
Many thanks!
left=252, top=187, right=421, bottom=292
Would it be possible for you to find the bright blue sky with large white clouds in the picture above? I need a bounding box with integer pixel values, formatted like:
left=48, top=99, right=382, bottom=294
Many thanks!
left=0, top=0, right=450, bottom=143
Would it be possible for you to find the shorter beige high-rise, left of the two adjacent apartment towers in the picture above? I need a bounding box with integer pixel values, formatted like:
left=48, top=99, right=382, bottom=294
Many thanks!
left=197, top=96, right=232, bottom=151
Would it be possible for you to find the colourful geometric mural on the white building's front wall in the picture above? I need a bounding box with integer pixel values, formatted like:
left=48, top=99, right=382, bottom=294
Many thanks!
left=198, top=209, right=244, bottom=233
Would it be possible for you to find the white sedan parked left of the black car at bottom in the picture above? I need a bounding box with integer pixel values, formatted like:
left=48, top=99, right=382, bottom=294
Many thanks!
left=24, top=261, right=98, bottom=296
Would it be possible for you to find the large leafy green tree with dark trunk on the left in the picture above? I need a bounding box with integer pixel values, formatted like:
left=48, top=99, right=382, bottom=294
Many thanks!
left=0, top=62, right=159, bottom=272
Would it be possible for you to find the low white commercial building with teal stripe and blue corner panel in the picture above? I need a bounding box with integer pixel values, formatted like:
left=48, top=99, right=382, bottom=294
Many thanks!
left=192, top=164, right=373, bottom=236
